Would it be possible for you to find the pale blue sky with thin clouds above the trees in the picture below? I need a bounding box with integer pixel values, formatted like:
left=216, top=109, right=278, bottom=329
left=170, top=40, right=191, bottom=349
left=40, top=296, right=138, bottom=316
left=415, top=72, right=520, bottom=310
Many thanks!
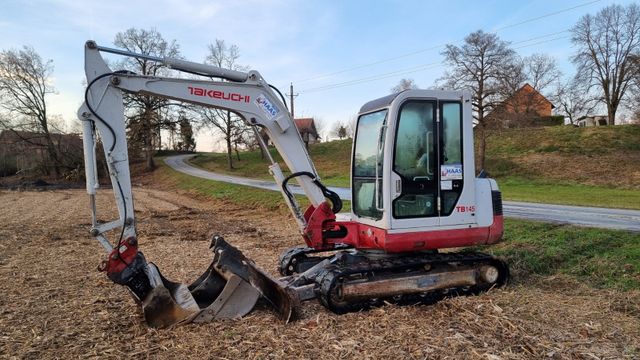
left=0, top=0, right=632, bottom=151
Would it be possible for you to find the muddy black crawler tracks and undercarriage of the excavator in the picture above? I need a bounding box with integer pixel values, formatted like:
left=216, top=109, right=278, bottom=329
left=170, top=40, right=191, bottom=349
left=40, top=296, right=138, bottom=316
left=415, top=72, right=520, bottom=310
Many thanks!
left=279, top=242, right=509, bottom=314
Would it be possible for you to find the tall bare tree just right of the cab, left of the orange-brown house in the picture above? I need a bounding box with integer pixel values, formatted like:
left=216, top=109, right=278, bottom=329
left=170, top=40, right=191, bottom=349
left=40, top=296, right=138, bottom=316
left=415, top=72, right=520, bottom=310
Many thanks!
left=440, top=30, right=515, bottom=169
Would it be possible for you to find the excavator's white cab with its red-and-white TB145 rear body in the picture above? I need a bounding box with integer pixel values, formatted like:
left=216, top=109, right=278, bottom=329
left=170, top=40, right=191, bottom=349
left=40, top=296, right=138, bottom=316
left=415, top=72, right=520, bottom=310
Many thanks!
left=342, top=90, right=502, bottom=252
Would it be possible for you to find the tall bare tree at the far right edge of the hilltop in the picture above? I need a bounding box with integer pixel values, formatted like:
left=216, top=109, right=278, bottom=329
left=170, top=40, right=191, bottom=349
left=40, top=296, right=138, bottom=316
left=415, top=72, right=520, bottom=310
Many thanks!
left=571, top=3, right=640, bottom=125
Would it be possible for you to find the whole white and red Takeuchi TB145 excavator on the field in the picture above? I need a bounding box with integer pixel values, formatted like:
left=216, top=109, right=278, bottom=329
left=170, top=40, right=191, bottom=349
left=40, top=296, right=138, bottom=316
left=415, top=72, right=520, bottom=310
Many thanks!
left=78, top=41, right=509, bottom=328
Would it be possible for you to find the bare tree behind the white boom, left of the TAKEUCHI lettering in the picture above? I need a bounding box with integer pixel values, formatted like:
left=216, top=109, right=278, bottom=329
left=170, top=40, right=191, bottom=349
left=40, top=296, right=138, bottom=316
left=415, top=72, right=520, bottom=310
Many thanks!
left=113, top=28, right=180, bottom=170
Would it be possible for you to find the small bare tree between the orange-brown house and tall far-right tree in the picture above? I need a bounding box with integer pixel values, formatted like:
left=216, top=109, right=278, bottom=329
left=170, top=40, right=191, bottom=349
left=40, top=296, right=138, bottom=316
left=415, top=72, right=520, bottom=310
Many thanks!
left=551, top=78, right=597, bottom=125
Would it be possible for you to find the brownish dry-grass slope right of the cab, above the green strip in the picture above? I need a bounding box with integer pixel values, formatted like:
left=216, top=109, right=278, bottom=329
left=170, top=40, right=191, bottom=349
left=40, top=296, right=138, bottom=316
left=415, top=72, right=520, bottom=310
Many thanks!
left=487, top=125, right=640, bottom=190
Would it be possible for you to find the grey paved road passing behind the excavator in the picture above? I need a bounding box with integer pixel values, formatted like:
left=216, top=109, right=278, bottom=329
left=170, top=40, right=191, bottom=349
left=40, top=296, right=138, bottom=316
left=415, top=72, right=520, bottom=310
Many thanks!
left=164, top=155, right=640, bottom=232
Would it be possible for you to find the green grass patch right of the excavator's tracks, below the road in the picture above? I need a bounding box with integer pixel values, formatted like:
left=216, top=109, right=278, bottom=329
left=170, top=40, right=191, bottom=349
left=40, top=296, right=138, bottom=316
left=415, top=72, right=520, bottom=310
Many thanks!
left=492, top=219, right=640, bottom=290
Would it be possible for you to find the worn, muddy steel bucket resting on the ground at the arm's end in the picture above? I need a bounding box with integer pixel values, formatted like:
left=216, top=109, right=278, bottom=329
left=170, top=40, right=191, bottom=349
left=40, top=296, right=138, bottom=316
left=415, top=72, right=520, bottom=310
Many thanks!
left=135, top=236, right=299, bottom=328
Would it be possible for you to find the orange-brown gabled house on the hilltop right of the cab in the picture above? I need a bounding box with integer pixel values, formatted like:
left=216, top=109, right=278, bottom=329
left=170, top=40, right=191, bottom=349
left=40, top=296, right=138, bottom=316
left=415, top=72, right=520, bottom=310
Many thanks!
left=487, top=84, right=563, bottom=128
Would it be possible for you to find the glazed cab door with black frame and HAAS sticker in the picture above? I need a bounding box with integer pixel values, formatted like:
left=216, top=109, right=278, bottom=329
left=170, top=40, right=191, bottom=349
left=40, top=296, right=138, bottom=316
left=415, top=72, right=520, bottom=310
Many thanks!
left=390, top=99, right=464, bottom=231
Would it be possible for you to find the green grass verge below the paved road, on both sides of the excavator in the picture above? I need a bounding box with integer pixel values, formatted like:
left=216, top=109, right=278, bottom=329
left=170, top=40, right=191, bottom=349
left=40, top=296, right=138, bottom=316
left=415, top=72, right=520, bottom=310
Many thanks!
left=155, top=161, right=640, bottom=290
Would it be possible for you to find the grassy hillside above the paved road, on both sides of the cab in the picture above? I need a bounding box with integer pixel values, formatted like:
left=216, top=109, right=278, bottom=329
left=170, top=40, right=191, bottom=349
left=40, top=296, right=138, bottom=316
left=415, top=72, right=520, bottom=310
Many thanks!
left=192, top=125, right=640, bottom=208
